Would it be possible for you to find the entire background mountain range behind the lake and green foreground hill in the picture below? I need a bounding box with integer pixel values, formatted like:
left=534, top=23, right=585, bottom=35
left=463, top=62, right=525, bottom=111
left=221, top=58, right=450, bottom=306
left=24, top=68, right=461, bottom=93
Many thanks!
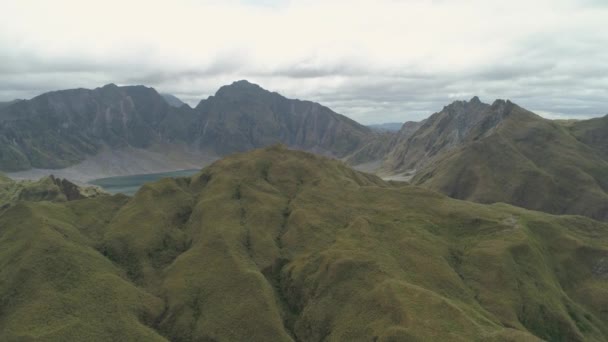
left=0, top=81, right=608, bottom=224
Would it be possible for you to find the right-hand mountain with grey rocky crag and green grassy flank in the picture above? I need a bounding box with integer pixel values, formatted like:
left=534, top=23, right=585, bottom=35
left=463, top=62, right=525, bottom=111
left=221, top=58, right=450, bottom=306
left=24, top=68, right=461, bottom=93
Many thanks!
left=400, top=100, right=608, bottom=220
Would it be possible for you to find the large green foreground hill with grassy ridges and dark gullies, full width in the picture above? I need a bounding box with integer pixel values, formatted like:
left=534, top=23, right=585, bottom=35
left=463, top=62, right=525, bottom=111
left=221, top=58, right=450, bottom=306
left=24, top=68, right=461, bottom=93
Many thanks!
left=0, top=146, right=608, bottom=341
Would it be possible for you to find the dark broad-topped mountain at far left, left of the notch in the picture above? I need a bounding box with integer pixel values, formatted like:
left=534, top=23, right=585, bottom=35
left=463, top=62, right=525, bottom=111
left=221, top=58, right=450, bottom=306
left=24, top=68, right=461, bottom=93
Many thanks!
left=0, top=84, right=183, bottom=171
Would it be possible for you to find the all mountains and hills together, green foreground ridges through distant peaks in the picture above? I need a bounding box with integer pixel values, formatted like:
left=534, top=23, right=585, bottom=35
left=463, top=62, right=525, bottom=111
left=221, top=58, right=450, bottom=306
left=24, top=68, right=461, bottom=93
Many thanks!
left=0, top=81, right=608, bottom=342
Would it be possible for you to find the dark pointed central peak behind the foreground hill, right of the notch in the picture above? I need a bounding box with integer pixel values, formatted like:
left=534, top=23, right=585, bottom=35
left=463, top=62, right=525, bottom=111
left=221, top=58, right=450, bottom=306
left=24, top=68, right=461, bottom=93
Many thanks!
left=194, top=81, right=375, bottom=158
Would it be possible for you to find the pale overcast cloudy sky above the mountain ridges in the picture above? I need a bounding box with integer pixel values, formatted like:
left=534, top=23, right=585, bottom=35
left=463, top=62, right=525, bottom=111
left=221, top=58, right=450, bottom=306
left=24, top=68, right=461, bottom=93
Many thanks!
left=0, top=0, right=608, bottom=124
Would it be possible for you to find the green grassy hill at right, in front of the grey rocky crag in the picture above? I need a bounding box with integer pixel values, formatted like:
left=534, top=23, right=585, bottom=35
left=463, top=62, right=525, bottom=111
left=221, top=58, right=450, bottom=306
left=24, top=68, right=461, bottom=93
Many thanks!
left=414, top=105, right=608, bottom=220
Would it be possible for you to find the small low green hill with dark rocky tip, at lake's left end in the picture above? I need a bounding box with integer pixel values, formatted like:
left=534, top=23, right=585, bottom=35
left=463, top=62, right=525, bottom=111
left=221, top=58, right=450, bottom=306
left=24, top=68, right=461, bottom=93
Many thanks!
left=0, top=174, right=107, bottom=210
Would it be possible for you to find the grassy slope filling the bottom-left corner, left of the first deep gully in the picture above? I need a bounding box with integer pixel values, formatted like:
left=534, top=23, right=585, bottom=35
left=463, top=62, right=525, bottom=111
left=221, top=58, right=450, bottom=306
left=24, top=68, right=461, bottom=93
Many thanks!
left=0, top=197, right=164, bottom=341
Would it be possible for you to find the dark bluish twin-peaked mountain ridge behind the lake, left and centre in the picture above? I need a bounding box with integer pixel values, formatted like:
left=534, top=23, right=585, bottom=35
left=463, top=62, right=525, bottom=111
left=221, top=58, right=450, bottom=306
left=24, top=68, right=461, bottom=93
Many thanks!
left=0, top=81, right=381, bottom=171
